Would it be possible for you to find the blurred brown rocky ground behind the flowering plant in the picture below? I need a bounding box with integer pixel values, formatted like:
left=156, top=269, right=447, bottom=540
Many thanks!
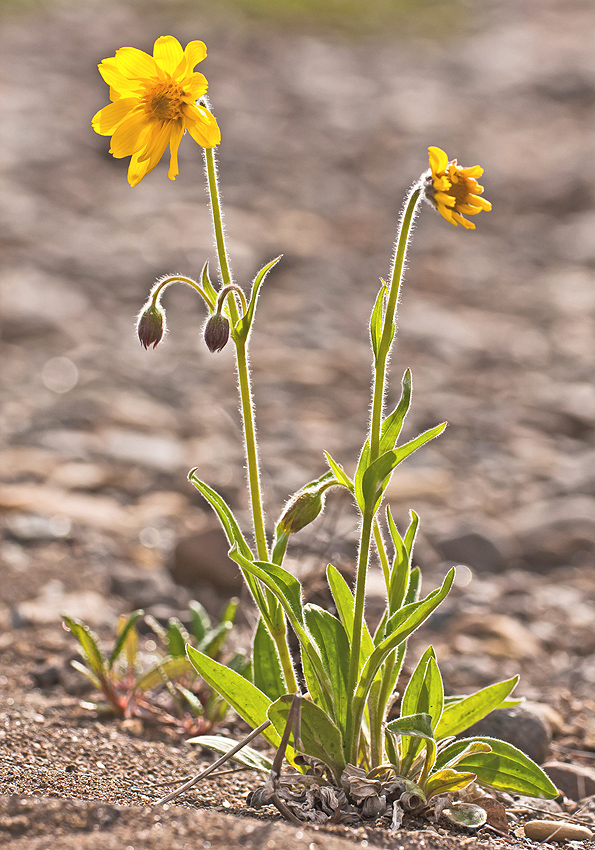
left=0, top=0, right=595, bottom=728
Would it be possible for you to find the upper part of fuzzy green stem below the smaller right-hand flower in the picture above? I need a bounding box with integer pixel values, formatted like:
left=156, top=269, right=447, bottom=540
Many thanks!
left=370, top=183, right=421, bottom=463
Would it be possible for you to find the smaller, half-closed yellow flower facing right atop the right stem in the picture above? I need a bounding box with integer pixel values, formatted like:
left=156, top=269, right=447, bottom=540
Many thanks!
left=426, top=147, right=492, bottom=230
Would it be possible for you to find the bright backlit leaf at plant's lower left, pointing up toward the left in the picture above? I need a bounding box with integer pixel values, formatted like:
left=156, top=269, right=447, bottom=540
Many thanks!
left=187, top=646, right=281, bottom=747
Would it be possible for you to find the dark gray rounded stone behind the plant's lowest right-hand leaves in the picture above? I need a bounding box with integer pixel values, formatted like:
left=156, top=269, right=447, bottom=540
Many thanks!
left=464, top=706, right=551, bottom=764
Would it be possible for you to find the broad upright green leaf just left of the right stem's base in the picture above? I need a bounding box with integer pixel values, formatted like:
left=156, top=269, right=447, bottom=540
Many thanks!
left=304, top=604, right=351, bottom=734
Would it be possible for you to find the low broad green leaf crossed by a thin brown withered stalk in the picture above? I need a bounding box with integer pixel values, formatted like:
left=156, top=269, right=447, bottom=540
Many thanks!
left=268, top=694, right=345, bottom=782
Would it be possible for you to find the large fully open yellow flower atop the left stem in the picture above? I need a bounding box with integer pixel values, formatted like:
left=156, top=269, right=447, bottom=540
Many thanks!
left=92, top=35, right=221, bottom=186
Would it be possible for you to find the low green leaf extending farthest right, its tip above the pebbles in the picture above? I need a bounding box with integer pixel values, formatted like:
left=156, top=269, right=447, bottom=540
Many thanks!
left=457, top=737, right=558, bottom=800
